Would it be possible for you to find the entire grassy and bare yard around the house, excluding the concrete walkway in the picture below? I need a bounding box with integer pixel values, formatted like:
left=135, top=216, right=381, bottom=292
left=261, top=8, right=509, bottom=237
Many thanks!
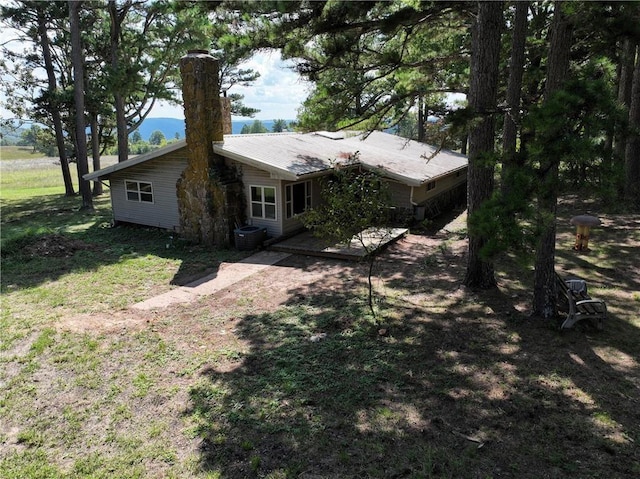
left=0, top=159, right=640, bottom=478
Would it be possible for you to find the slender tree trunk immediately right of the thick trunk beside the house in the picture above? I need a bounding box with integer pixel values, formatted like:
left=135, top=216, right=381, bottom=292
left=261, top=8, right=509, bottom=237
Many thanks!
left=501, top=2, right=529, bottom=197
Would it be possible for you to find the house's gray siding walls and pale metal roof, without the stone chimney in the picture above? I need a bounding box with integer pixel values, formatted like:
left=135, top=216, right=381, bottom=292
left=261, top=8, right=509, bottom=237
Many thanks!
left=85, top=131, right=467, bottom=237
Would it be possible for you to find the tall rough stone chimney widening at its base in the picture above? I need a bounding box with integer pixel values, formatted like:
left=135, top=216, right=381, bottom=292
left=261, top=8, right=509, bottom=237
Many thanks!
left=177, top=50, right=242, bottom=247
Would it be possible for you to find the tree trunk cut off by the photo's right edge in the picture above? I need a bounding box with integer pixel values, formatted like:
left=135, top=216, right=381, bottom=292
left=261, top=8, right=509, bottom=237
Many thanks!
left=624, top=45, right=640, bottom=207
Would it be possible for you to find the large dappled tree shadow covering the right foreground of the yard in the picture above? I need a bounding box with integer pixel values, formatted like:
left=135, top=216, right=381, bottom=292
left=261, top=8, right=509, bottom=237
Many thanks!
left=186, top=208, right=640, bottom=478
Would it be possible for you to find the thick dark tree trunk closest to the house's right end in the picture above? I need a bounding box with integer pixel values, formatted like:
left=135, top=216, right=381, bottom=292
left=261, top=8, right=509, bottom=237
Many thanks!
left=464, top=1, right=503, bottom=289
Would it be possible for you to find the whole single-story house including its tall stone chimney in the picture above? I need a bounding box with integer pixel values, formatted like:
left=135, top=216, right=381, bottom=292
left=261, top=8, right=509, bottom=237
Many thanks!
left=85, top=52, right=467, bottom=248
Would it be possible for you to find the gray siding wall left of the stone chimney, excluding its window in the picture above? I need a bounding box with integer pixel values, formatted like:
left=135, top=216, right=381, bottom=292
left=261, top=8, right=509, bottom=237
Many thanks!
left=109, top=148, right=187, bottom=231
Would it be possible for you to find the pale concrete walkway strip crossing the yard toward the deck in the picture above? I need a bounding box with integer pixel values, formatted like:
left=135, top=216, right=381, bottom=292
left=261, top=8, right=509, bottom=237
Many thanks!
left=131, top=251, right=291, bottom=310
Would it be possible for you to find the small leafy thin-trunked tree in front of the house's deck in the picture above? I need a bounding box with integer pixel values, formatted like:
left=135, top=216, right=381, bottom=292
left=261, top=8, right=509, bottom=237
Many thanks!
left=302, top=152, right=391, bottom=316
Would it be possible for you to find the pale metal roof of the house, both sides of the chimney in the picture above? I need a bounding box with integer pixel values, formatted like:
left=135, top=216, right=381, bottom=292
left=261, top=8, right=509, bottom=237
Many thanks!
left=85, top=131, right=468, bottom=186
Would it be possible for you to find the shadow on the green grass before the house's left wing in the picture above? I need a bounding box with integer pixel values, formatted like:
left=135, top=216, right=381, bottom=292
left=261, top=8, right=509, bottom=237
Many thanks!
left=2, top=195, right=247, bottom=291
